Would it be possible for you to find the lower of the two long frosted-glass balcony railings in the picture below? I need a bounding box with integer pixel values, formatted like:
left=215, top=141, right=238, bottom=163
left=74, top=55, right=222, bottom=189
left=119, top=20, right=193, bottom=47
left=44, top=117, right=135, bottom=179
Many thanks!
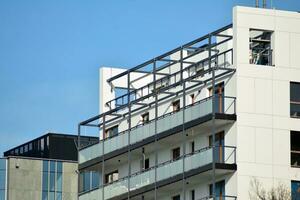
left=80, top=146, right=236, bottom=200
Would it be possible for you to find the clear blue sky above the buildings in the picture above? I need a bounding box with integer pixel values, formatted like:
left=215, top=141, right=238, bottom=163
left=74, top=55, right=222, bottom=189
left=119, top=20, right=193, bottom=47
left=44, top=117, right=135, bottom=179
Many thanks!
left=0, top=0, right=300, bottom=153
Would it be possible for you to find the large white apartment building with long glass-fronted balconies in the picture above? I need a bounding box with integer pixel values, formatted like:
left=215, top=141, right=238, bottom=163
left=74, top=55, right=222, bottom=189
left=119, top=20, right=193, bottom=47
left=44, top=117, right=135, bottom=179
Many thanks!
left=78, top=6, right=300, bottom=200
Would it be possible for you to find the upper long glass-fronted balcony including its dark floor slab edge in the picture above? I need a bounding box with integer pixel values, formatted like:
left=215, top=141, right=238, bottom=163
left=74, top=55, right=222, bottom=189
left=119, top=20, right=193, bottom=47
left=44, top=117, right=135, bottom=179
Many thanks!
left=79, top=96, right=235, bottom=168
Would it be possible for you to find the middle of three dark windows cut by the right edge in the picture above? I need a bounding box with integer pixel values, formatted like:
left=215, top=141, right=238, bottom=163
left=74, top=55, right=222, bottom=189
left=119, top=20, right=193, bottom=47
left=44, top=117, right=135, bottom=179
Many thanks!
left=290, top=131, right=300, bottom=167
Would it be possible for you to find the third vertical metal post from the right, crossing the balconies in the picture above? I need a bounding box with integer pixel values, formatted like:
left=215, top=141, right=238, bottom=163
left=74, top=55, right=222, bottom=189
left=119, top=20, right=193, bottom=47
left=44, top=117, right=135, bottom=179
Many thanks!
left=153, top=59, right=158, bottom=200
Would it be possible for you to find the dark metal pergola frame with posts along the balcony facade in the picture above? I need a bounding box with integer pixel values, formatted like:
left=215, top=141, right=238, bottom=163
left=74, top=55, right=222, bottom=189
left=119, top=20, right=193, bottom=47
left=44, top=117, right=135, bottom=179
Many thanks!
left=78, top=24, right=235, bottom=199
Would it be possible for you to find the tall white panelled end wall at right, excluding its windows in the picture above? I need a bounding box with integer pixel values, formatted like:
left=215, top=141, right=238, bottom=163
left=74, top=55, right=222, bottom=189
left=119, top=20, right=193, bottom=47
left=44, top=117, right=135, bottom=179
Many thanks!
left=233, top=7, right=300, bottom=199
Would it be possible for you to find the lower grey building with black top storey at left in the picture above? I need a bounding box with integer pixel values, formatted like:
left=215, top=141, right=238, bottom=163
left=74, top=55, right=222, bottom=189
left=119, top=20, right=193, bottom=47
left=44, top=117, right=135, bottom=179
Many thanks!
left=0, top=133, right=99, bottom=200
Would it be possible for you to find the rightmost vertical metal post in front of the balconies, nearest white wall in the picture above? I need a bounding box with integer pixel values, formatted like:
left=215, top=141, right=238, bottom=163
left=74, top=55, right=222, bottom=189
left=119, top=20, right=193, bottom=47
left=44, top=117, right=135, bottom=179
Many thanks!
left=208, top=34, right=216, bottom=200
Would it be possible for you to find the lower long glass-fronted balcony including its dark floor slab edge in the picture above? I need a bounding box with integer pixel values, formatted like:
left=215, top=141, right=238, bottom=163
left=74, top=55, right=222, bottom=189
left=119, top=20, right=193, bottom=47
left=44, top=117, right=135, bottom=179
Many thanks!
left=79, top=146, right=236, bottom=200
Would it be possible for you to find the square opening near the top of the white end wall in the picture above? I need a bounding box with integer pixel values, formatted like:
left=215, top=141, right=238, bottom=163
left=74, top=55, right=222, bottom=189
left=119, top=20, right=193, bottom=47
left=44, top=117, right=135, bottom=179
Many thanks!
left=249, top=29, right=273, bottom=66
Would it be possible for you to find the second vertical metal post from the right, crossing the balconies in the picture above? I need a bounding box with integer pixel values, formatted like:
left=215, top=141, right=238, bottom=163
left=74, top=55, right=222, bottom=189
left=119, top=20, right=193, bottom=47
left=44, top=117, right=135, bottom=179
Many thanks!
left=180, top=47, right=186, bottom=200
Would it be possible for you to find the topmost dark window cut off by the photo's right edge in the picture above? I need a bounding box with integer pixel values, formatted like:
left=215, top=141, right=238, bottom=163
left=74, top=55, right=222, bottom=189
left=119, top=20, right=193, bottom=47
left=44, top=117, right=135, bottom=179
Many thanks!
left=290, top=82, right=300, bottom=118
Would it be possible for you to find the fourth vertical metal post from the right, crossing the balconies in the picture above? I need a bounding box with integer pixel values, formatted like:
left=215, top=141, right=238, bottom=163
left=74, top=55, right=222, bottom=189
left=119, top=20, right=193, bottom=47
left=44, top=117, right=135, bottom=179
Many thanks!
left=127, top=72, right=131, bottom=200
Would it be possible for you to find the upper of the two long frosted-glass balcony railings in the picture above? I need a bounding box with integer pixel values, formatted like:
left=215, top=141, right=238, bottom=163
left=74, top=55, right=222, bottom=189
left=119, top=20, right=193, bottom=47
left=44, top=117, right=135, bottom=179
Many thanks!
left=79, top=96, right=235, bottom=163
